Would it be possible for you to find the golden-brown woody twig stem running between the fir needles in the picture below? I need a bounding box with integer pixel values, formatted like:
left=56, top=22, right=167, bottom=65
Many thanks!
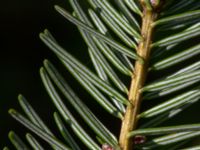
left=119, top=1, right=157, bottom=150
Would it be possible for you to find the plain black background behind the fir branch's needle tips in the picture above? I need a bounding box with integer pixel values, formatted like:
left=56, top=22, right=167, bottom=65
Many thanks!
left=0, top=0, right=200, bottom=149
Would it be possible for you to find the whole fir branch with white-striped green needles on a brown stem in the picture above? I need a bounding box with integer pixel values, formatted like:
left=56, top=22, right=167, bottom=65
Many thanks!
left=4, top=0, right=200, bottom=150
